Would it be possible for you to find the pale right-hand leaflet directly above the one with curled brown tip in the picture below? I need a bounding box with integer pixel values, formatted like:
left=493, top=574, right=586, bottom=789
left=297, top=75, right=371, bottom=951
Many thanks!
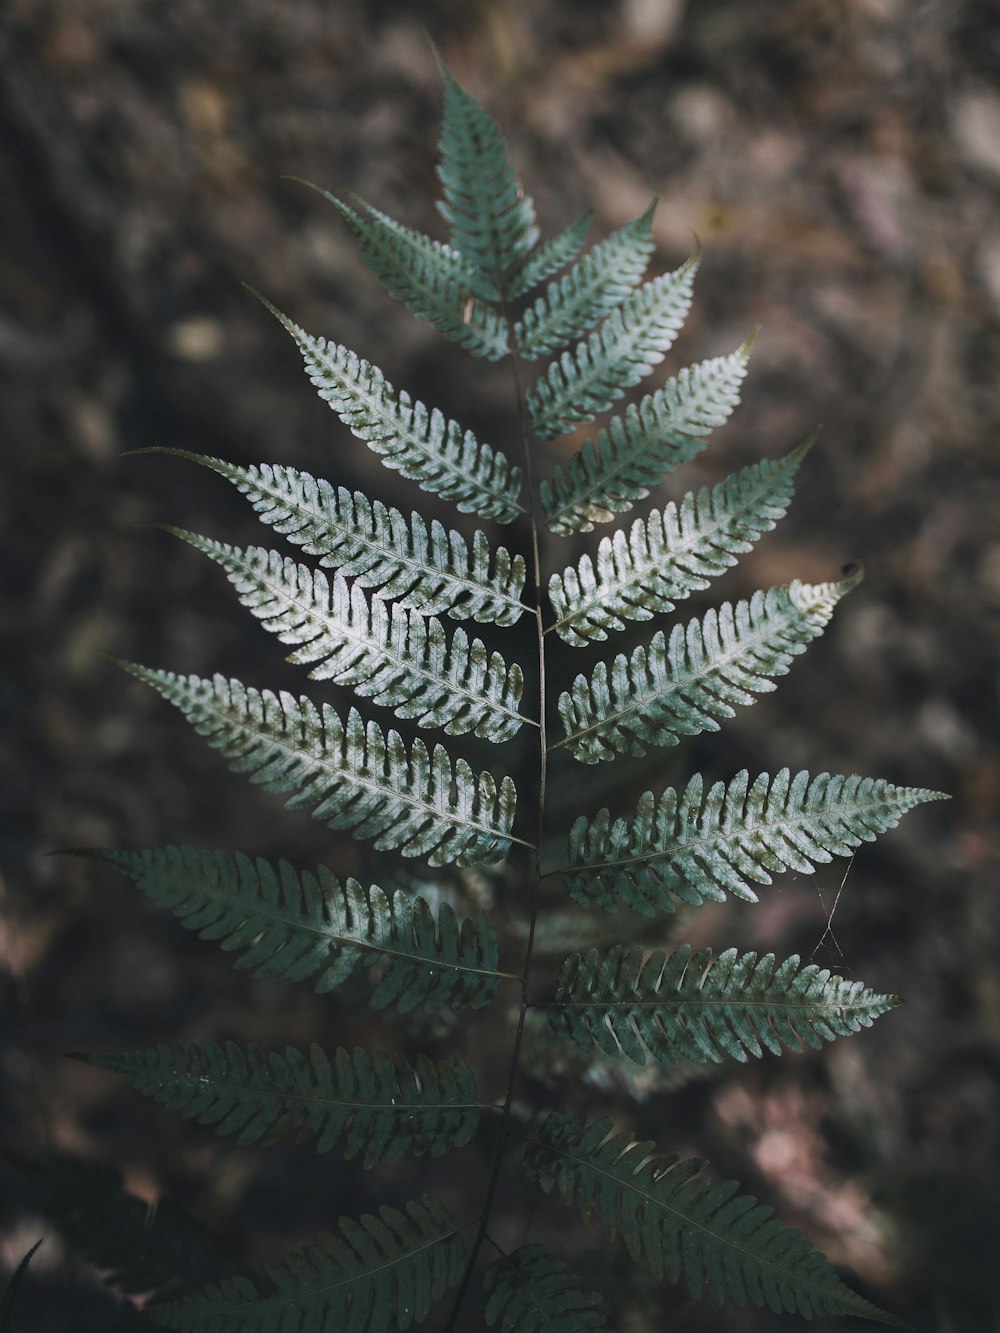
left=548, top=441, right=812, bottom=648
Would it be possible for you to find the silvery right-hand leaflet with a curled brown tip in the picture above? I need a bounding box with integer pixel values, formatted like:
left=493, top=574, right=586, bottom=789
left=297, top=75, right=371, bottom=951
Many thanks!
left=553, top=575, right=860, bottom=764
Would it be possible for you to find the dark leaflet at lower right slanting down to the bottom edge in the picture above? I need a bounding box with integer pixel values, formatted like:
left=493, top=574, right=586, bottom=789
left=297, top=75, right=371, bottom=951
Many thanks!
left=524, top=1112, right=905, bottom=1328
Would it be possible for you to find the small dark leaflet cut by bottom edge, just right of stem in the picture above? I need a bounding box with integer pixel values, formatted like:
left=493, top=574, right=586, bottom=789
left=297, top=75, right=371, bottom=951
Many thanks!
left=483, top=1245, right=611, bottom=1333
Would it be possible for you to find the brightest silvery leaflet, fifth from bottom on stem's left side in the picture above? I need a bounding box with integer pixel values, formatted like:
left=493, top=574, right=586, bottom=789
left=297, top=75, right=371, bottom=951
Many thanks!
left=168, top=528, right=524, bottom=742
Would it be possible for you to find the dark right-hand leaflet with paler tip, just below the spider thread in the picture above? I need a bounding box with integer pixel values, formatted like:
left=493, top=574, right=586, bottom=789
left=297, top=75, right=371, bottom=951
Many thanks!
left=548, top=944, right=903, bottom=1066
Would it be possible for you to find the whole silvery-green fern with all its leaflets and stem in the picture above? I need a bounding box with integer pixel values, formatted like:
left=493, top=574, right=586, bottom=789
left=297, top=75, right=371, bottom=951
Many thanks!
left=60, top=59, right=937, bottom=1333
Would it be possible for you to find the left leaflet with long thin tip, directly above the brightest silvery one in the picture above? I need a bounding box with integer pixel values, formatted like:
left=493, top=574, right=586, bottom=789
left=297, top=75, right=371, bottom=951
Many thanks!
left=146, top=449, right=525, bottom=625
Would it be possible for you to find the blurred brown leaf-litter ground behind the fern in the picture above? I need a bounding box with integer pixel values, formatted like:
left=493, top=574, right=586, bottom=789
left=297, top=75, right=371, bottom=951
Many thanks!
left=0, top=0, right=1000, bottom=1333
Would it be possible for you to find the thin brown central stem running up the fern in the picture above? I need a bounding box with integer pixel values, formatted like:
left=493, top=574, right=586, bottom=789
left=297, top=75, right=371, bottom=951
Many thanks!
left=445, top=309, right=548, bottom=1333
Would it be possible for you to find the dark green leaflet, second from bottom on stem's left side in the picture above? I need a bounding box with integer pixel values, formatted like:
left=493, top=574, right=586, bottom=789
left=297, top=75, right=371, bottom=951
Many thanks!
left=76, top=1041, right=479, bottom=1168
